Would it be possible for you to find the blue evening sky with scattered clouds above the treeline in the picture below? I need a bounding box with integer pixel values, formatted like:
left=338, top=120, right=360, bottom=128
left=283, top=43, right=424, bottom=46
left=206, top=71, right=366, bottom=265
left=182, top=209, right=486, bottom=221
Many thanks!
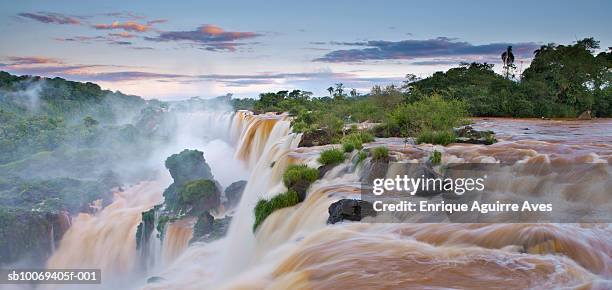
left=0, top=0, right=612, bottom=100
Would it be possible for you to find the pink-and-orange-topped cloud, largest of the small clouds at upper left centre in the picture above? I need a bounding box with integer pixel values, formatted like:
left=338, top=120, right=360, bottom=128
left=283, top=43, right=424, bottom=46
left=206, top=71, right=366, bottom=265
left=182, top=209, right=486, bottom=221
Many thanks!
left=145, top=24, right=261, bottom=51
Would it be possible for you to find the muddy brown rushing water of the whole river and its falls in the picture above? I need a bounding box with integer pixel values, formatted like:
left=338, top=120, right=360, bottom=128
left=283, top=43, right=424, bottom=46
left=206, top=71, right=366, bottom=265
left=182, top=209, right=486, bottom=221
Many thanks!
left=40, top=112, right=612, bottom=289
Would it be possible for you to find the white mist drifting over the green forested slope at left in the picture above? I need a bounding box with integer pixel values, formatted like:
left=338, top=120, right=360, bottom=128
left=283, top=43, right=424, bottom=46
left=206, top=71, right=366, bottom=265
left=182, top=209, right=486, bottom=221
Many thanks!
left=0, top=75, right=248, bottom=266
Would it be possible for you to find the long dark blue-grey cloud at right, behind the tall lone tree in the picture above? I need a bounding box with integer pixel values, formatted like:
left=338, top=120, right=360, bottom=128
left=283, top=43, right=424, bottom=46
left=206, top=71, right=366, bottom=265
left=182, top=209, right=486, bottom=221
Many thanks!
left=314, top=37, right=539, bottom=63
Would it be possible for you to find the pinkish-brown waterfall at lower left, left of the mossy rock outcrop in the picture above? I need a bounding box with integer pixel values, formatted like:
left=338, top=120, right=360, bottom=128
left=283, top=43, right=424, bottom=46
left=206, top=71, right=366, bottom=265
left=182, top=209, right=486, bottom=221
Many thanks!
left=47, top=178, right=169, bottom=278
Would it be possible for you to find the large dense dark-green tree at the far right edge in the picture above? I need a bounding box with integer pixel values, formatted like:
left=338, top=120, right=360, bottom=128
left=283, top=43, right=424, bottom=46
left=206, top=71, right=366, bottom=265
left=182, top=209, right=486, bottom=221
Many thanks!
left=521, top=38, right=610, bottom=117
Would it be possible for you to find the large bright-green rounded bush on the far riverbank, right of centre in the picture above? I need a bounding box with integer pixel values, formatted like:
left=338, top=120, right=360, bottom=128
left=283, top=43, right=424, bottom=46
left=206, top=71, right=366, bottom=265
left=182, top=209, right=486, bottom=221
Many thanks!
left=387, top=94, right=467, bottom=137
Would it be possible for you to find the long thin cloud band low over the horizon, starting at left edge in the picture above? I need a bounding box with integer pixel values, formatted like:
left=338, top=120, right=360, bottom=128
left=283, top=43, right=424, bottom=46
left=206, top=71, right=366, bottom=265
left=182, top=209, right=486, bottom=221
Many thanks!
left=0, top=57, right=403, bottom=91
